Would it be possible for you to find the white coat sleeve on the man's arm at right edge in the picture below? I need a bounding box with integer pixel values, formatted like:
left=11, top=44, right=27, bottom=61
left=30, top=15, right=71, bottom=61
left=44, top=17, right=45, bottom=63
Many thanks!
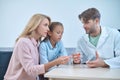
left=104, top=31, right=120, bottom=68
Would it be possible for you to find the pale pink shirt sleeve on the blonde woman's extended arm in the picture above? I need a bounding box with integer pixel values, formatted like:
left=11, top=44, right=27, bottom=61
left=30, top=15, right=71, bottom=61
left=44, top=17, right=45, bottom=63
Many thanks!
left=17, top=42, right=45, bottom=76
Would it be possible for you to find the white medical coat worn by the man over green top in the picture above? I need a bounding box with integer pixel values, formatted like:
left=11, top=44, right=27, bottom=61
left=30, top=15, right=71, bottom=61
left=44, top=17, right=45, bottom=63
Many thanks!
left=76, top=27, right=120, bottom=68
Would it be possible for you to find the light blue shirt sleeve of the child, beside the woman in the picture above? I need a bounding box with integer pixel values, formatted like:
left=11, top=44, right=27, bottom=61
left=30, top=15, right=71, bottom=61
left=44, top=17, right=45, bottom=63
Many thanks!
left=39, top=42, right=49, bottom=64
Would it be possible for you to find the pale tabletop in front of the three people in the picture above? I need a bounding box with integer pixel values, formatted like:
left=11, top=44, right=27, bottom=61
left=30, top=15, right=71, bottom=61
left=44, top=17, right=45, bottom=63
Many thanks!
left=44, top=64, right=120, bottom=80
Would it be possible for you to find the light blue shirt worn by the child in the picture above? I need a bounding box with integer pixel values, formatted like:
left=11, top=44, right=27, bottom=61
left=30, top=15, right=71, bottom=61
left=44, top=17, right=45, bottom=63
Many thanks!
left=39, top=40, right=67, bottom=64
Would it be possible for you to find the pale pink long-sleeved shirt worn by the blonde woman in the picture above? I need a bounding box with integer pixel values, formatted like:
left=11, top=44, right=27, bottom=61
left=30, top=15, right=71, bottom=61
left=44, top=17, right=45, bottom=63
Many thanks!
left=4, top=38, right=45, bottom=80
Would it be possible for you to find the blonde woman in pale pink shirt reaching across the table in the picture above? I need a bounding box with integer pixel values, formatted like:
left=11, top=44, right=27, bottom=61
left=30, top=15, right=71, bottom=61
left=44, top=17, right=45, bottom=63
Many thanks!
left=4, top=14, right=69, bottom=80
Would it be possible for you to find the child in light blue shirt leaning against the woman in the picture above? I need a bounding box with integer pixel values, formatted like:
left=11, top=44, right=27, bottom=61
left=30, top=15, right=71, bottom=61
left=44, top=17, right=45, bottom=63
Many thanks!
left=39, top=22, right=67, bottom=67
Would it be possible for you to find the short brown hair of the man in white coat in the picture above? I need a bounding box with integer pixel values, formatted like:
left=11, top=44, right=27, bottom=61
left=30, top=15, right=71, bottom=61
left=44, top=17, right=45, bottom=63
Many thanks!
left=78, top=8, right=101, bottom=23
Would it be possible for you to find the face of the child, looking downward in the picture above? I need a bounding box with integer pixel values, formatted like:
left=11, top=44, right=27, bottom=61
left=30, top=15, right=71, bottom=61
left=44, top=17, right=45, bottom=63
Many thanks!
left=49, top=25, right=64, bottom=42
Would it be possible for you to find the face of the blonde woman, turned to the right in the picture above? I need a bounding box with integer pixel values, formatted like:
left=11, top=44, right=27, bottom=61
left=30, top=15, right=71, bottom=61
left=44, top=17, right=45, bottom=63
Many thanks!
left=37, top=18, right=49, bottom=37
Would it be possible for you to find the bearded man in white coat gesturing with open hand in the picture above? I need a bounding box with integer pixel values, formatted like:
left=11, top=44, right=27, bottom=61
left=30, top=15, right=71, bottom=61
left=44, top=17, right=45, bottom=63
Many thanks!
left=73, top=8, right=120, bottom=68
